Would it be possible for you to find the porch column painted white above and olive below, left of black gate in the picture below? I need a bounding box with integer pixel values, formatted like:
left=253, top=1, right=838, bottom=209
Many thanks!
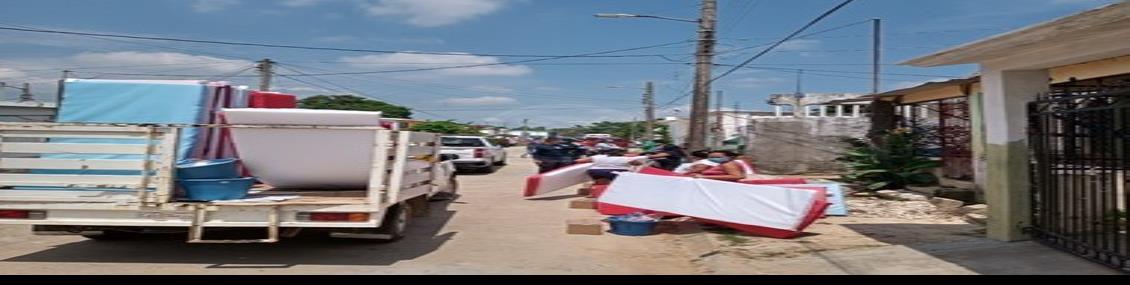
left=974, top=67, right=1051, bottom=241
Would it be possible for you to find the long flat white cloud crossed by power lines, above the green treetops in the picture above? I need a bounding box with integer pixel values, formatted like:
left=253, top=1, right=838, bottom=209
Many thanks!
left=341, top=53, right=533, bottom=77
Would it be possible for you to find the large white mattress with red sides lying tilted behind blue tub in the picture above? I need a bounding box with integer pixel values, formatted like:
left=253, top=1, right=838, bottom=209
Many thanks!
left=599, top=173, right=828, bottom=239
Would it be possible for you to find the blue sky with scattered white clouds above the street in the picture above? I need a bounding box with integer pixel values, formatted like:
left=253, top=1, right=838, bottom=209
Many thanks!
left=0, top=0, right=1113, bottom=127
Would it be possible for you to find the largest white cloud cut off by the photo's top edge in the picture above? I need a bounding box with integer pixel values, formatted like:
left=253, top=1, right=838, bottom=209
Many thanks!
left=366, top=0, right=511, bottom=27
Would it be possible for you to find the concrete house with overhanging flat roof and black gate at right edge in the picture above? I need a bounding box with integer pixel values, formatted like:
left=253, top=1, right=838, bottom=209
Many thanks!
left=905, top=1, right=1130, bottom=268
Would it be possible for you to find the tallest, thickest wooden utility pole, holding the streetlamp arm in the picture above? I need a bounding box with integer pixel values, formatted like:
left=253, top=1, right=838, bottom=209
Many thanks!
left=687, top=0, right=718, bottom=149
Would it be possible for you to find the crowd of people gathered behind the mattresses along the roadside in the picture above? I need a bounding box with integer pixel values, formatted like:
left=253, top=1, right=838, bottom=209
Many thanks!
left=530, top=138, right=757, bottom=184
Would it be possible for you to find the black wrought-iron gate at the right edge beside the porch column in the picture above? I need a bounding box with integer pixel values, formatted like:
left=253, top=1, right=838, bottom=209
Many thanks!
left=1027, top=87, right=1130, bottom=271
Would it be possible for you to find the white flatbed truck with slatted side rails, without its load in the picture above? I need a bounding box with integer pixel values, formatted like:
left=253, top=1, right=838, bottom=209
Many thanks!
left=0, top=123, right=458, bottom=243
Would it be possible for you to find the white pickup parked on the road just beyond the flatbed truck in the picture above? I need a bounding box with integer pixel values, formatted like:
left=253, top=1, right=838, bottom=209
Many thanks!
left=440, top=136, right=506, bottom=171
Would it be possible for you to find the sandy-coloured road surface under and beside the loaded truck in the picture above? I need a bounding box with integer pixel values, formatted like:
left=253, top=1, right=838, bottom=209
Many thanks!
left=0, top=148, right=696, bottom=275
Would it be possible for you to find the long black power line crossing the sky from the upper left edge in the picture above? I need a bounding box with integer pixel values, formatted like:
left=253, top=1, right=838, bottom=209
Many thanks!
left=0, top=26, right=696, bottom=59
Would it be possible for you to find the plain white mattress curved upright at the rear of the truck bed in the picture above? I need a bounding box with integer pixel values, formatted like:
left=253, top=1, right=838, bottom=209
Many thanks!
left=224, top=109, right=381, bottom=190
